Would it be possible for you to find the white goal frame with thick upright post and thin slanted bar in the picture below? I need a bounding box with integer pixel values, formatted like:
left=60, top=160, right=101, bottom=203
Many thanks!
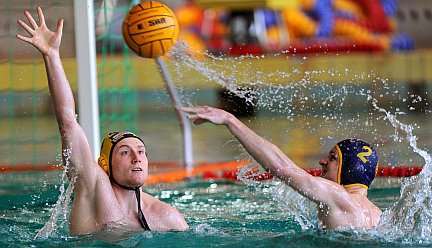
left=74, top=0, right=193, bottom=171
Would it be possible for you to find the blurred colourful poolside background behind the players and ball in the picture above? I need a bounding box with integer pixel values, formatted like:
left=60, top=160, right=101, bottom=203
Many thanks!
left=0, top=0, right=432, bottom=168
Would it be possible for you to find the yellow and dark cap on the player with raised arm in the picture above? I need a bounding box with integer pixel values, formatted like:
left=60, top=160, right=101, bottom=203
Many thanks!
left=98, top=132, right=144, bottom=178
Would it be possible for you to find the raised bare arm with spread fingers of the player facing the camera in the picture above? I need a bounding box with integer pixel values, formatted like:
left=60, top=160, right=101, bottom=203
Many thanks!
left=16, top=7, right=95, bottom=182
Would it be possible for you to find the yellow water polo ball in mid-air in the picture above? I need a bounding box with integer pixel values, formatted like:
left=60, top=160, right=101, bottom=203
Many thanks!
left=122, top=1, right=179, bottom=58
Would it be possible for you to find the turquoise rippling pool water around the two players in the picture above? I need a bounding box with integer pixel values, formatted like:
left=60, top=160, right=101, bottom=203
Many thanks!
left=0, top=171, right=418, bottom=247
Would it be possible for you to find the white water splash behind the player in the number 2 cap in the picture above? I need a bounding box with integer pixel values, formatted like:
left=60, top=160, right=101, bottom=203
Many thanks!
left=370, top=97, right=432, bottom=243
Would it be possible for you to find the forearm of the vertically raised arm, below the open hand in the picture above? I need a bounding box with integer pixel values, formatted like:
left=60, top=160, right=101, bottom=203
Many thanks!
left=43, top=51, right=76, bottom=131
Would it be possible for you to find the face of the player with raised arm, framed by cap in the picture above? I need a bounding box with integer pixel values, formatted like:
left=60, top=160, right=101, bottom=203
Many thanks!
left=111, top=138, right=148, bottom=187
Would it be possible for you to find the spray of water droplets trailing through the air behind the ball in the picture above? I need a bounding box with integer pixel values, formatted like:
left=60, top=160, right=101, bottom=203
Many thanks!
left=170, top=42, right=380, bottom=127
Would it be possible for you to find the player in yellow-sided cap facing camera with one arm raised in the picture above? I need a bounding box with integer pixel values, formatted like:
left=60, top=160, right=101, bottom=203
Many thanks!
left=17, top=7, right=188, bottom=236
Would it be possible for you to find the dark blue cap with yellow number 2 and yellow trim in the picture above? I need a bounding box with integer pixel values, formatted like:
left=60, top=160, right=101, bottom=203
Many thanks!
left=335, top=139, right=378, bottom=189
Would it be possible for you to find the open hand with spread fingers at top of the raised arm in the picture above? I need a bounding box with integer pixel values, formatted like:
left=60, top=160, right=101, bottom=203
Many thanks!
left=16, top=7, right=63, bottom=55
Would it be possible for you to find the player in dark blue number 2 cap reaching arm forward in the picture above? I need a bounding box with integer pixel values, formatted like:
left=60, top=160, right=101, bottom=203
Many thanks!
left=181, top=106, right=381, bottom=229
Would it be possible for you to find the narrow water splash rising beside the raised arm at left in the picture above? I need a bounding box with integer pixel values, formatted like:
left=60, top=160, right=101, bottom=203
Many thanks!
left=35, top=148, right=76, bottom=238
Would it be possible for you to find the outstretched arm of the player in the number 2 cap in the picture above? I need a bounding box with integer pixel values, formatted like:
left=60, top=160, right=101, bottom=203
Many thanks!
left=181, top=106, right=338, bottom=203
